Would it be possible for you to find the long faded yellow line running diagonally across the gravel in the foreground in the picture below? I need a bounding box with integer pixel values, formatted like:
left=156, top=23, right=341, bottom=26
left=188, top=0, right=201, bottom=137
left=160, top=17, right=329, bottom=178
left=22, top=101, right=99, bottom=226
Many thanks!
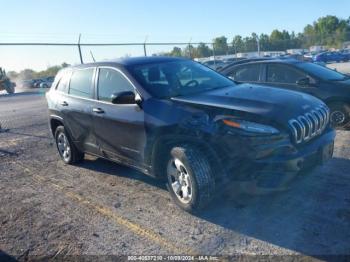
left=17, top=162, right=197, bottom=256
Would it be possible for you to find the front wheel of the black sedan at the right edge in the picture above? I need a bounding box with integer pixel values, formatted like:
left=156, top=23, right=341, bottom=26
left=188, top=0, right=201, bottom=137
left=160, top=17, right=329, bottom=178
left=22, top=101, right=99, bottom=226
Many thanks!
left=329, top=102, right=350, bottom=128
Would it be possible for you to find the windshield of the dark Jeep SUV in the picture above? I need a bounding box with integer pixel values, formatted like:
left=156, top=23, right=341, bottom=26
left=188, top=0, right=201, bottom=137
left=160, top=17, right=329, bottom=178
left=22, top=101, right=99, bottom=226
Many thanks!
left=129, top=61, right=234, bottom=98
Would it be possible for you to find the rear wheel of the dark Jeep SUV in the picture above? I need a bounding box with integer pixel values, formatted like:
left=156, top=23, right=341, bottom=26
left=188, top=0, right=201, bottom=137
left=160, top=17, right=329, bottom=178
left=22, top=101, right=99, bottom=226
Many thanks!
left=55, top=126, right=84, bottom=164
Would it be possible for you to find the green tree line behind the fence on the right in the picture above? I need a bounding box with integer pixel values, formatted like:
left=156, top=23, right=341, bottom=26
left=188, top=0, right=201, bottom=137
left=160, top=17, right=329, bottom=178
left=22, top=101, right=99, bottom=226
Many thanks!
left=162, top=15, right=350, bottom=58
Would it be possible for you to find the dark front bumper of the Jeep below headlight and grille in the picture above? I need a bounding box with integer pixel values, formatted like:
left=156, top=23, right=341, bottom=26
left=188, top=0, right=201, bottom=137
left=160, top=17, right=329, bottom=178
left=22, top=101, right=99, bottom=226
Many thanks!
left=219, top=129, right=335, bottom=188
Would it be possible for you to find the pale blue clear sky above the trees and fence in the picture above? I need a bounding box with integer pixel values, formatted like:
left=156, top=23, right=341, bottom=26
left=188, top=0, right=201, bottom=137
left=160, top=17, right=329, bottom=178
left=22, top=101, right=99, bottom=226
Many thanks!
left=0, top=0, right=350, bottom=71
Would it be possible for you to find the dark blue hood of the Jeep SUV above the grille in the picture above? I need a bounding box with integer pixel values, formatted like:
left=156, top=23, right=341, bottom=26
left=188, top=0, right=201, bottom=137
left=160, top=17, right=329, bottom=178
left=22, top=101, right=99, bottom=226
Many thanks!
left=172, top=84, right=324, bottom=126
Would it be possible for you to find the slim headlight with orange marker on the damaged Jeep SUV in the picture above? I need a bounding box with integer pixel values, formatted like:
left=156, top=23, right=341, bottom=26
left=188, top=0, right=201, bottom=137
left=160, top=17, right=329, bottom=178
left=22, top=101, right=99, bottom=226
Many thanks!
left=222, top=118, right=279, bottom=134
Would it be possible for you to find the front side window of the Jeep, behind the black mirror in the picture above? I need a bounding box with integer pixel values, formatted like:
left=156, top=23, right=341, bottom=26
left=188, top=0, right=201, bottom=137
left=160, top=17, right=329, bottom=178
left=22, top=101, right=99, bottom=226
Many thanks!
left=97, top=68, right=134, bottom=102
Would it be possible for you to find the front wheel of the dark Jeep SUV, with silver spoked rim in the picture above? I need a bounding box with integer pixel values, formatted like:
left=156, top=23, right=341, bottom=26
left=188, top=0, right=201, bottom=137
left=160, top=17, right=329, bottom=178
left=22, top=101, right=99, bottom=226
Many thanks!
left=166, top=145, right=215, bottom=213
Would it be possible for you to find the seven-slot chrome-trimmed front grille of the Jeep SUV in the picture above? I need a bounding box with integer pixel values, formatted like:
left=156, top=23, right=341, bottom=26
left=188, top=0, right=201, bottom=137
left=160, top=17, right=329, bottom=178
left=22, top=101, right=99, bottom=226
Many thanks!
left=288, top=106, right=329, bottom=144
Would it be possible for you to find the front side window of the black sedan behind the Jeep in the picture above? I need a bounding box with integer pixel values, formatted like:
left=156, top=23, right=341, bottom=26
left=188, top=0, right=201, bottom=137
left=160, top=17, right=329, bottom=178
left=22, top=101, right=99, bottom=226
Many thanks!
left=267, top=64, right=307, bottom=84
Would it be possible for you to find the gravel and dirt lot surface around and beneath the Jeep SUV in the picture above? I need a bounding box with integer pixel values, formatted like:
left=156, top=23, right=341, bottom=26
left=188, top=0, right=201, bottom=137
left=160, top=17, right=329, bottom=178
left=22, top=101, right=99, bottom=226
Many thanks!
left=0, top=92, right=350, bottom=260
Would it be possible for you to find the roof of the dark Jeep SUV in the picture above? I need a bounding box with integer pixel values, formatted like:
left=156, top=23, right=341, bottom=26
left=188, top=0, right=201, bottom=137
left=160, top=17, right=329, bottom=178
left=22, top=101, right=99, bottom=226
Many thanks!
left=72, top=56, right=187, bottom=68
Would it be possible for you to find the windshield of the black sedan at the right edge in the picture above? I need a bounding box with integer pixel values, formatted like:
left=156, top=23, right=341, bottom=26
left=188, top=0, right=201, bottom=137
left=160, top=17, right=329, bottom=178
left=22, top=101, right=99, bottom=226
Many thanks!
left=297, top=63, right=348, bottom=81
